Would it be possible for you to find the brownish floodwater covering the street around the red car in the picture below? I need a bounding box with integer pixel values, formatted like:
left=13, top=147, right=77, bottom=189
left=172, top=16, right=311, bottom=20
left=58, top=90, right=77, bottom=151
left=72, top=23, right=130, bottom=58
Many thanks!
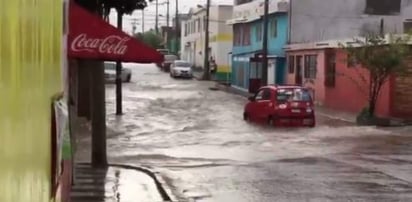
left=106, top=65, right=412, bottom=202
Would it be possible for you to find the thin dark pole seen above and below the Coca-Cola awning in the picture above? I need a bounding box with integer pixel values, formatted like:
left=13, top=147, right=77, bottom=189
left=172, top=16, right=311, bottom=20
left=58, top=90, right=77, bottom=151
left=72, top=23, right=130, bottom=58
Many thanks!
left=116, top=9, right=123, bottom=115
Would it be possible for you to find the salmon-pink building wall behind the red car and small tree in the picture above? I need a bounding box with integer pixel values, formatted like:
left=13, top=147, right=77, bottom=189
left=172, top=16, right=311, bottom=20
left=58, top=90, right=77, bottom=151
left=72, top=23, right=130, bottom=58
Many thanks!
left=286, top=49, right=393, bottom=117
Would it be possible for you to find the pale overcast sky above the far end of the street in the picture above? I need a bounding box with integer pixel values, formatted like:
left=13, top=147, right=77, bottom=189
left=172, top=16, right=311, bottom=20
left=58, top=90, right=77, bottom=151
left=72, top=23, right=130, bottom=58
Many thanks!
left=110, top=0, right=233, bottom=33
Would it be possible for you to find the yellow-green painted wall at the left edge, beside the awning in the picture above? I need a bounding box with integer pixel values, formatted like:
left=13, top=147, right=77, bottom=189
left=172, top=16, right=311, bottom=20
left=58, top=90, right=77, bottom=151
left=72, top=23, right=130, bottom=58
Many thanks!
left=0, top=0, right=62, bottom=202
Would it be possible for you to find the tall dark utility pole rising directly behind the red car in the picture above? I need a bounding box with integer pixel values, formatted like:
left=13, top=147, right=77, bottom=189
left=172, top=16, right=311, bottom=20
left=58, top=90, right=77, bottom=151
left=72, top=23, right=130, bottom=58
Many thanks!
left=261, top=0, right=269, bottom=86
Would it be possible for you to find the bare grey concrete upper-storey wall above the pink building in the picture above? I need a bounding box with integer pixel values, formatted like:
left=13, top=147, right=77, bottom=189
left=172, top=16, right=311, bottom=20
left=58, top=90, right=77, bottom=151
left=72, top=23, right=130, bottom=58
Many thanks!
left=289, top=0, right=412, bottom=43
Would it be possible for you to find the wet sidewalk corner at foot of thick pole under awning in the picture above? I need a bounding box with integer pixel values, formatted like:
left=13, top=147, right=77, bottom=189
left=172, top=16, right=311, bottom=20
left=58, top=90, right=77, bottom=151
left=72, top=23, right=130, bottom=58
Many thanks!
left=71, top=163, right=163, bottom=202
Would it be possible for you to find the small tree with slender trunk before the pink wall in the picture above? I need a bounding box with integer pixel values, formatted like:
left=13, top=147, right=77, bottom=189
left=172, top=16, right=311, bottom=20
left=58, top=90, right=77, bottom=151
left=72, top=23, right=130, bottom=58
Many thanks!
left=341, top=33, right=411, bottom=118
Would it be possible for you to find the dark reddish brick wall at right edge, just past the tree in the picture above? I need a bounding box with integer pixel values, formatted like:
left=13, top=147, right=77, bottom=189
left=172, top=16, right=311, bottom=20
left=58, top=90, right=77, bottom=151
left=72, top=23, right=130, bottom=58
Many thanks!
left=392, top=58, right=412, bottom=118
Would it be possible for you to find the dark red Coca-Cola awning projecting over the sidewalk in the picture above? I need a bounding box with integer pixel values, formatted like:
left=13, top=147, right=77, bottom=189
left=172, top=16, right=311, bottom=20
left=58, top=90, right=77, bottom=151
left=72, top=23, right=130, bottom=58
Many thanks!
left=68, top=1, right=163, bottom=63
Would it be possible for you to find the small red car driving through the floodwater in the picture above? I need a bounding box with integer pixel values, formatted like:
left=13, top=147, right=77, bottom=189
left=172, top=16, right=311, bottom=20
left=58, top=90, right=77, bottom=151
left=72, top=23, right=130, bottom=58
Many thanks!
left=243, top=85, right=316, bottom=127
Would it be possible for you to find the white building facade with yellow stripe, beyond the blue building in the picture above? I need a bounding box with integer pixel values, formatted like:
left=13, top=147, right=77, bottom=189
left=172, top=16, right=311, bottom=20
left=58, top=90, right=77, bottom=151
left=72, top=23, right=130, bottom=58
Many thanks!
left=180, top=5, right=233, bottom=80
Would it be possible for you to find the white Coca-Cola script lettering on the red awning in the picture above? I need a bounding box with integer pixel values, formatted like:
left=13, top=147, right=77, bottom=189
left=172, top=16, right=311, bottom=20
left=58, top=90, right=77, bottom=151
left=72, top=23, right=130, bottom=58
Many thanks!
left=70, top=34, right=130, bottom=55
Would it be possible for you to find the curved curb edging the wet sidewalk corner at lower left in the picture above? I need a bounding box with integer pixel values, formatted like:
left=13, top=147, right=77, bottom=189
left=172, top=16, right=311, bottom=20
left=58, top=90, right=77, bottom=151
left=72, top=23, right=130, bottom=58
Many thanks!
left=77, top=162, right=178, bottom=202
